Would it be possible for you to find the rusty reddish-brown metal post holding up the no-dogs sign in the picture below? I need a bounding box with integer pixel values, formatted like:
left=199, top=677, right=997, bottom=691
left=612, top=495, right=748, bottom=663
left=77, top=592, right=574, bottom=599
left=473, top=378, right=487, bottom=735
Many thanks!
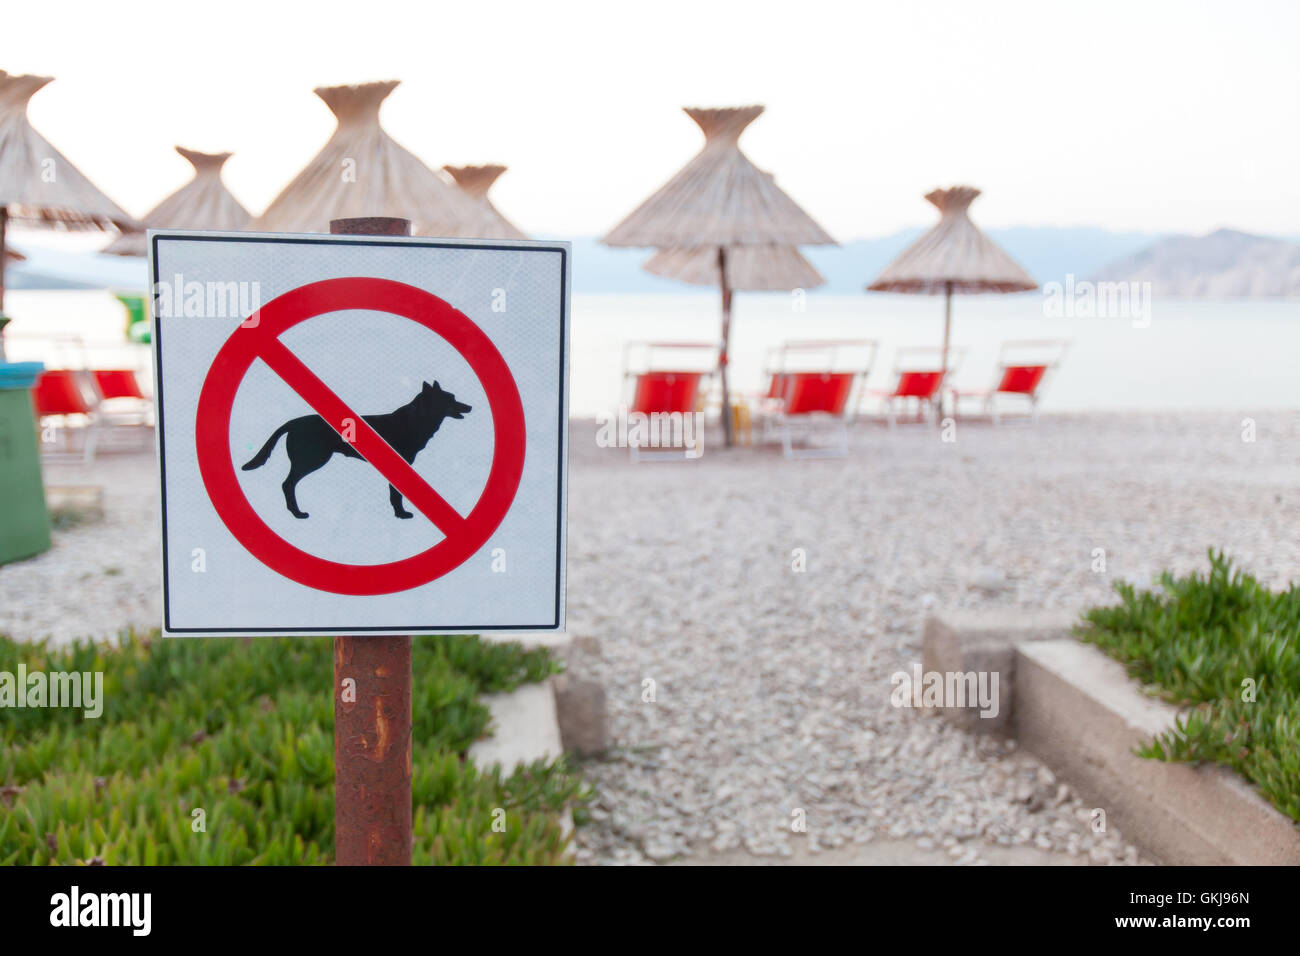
left=329, top=216, right=412, bottom=866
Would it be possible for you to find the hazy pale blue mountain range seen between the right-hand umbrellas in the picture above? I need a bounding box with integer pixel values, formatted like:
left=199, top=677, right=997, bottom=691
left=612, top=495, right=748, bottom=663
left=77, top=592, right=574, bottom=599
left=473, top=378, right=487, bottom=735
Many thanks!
left=559, top=226, right=1157, bottom=295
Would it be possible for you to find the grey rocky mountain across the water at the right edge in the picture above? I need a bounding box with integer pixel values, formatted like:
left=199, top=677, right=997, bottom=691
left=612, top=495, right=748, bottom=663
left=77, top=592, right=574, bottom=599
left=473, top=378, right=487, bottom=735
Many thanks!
left=1095, top=229, right=1300, bottom=299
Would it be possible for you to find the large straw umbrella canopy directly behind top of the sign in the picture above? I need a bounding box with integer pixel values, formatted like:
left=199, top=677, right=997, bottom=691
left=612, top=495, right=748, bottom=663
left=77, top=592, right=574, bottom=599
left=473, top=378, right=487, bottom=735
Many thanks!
left=250, top=79, right=482, bottom=235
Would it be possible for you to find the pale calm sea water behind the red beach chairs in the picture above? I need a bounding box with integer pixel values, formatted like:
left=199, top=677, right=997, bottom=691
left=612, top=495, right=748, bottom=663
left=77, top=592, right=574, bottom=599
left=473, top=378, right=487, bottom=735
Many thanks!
left=5, top=290, right=1300, bottom=418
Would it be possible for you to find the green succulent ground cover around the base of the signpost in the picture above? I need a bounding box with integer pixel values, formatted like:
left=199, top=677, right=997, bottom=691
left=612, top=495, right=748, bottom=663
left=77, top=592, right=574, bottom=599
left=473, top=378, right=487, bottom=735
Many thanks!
left=0, top=632, right=589, bottom=865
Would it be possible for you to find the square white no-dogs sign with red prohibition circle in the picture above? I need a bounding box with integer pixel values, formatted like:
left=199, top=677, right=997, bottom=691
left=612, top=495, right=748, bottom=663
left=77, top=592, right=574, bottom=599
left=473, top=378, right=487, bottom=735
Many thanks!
left=150, top=232, right=568, bottom=635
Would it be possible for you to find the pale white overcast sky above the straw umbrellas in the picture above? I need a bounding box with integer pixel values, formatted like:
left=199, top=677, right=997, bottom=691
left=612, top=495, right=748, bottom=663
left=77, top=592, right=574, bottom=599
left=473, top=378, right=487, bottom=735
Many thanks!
left=0, top=0, right=1300, bottom=239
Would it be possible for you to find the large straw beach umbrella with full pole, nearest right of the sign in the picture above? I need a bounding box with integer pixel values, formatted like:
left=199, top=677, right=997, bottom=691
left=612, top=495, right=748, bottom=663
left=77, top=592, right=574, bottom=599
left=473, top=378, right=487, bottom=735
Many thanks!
left=603, top=107, right=835, bottom=445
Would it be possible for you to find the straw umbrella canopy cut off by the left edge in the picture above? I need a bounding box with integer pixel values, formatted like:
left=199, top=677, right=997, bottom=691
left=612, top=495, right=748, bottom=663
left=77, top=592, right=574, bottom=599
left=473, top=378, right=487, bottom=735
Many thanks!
left=0, top=70, right=137, bottom=325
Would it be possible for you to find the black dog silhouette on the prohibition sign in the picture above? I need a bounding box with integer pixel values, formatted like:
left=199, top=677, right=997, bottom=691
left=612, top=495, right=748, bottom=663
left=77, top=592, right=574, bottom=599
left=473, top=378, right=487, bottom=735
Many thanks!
left=243, top=382, right=471, bottom=518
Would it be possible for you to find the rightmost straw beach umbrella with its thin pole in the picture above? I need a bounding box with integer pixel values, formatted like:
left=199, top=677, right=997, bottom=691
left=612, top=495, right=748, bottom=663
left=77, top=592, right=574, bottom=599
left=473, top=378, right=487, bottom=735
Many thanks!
left=867, top=186, right=1039, bottom=400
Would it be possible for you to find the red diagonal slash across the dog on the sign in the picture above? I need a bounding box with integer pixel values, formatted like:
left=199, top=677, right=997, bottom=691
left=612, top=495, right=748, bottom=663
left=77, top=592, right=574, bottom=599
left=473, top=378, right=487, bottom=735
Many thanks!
left=257, top=336, right=465, bottom=537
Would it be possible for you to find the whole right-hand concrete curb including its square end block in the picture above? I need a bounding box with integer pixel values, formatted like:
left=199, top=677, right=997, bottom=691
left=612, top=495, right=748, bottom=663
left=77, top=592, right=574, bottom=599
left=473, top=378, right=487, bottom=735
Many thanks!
left=923, top=610, right=1300, bottom=865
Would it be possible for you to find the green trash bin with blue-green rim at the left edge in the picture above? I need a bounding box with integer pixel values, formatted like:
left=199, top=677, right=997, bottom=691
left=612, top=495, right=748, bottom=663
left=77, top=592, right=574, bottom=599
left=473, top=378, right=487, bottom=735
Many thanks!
left=0, top=362, right=49, bottom=564
